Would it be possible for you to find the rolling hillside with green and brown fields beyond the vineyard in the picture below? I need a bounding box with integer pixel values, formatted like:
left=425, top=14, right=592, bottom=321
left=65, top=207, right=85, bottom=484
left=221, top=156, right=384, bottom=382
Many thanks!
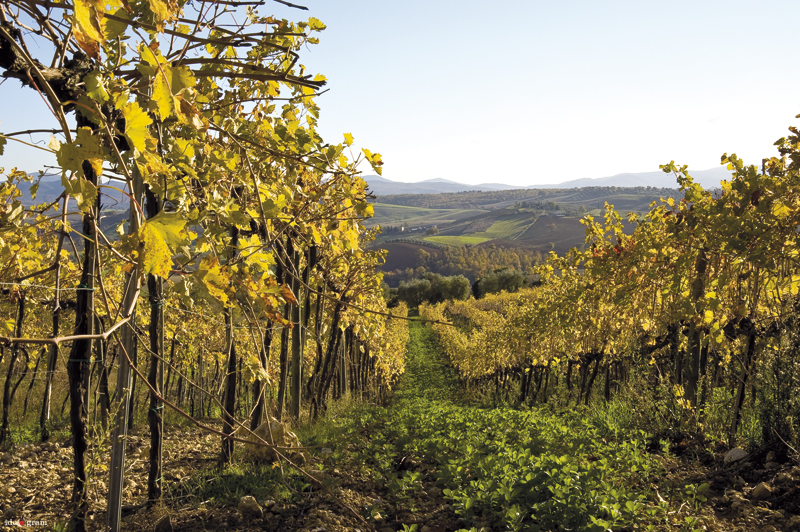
left=366, top=186, right=683, bottom=280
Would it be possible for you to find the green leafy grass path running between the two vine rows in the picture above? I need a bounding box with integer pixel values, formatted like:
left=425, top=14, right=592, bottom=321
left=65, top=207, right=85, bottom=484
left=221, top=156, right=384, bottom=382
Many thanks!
left=350, top=323, right=667, bottom=531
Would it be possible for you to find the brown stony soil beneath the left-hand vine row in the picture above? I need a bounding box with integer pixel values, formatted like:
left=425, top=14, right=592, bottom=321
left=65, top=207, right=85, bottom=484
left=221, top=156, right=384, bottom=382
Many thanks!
left=0, top=428, right=457, bottom=532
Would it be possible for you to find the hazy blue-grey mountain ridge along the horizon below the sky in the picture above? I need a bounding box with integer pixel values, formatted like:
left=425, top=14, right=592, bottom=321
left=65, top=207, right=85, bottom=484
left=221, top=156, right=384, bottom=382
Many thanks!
left=364, top=166, right=731, bottom=196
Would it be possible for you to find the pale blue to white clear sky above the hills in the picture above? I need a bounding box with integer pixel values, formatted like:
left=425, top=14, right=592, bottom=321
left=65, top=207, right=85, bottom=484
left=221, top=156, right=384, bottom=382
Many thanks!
left=0, top=0, right=800, bottom=186
